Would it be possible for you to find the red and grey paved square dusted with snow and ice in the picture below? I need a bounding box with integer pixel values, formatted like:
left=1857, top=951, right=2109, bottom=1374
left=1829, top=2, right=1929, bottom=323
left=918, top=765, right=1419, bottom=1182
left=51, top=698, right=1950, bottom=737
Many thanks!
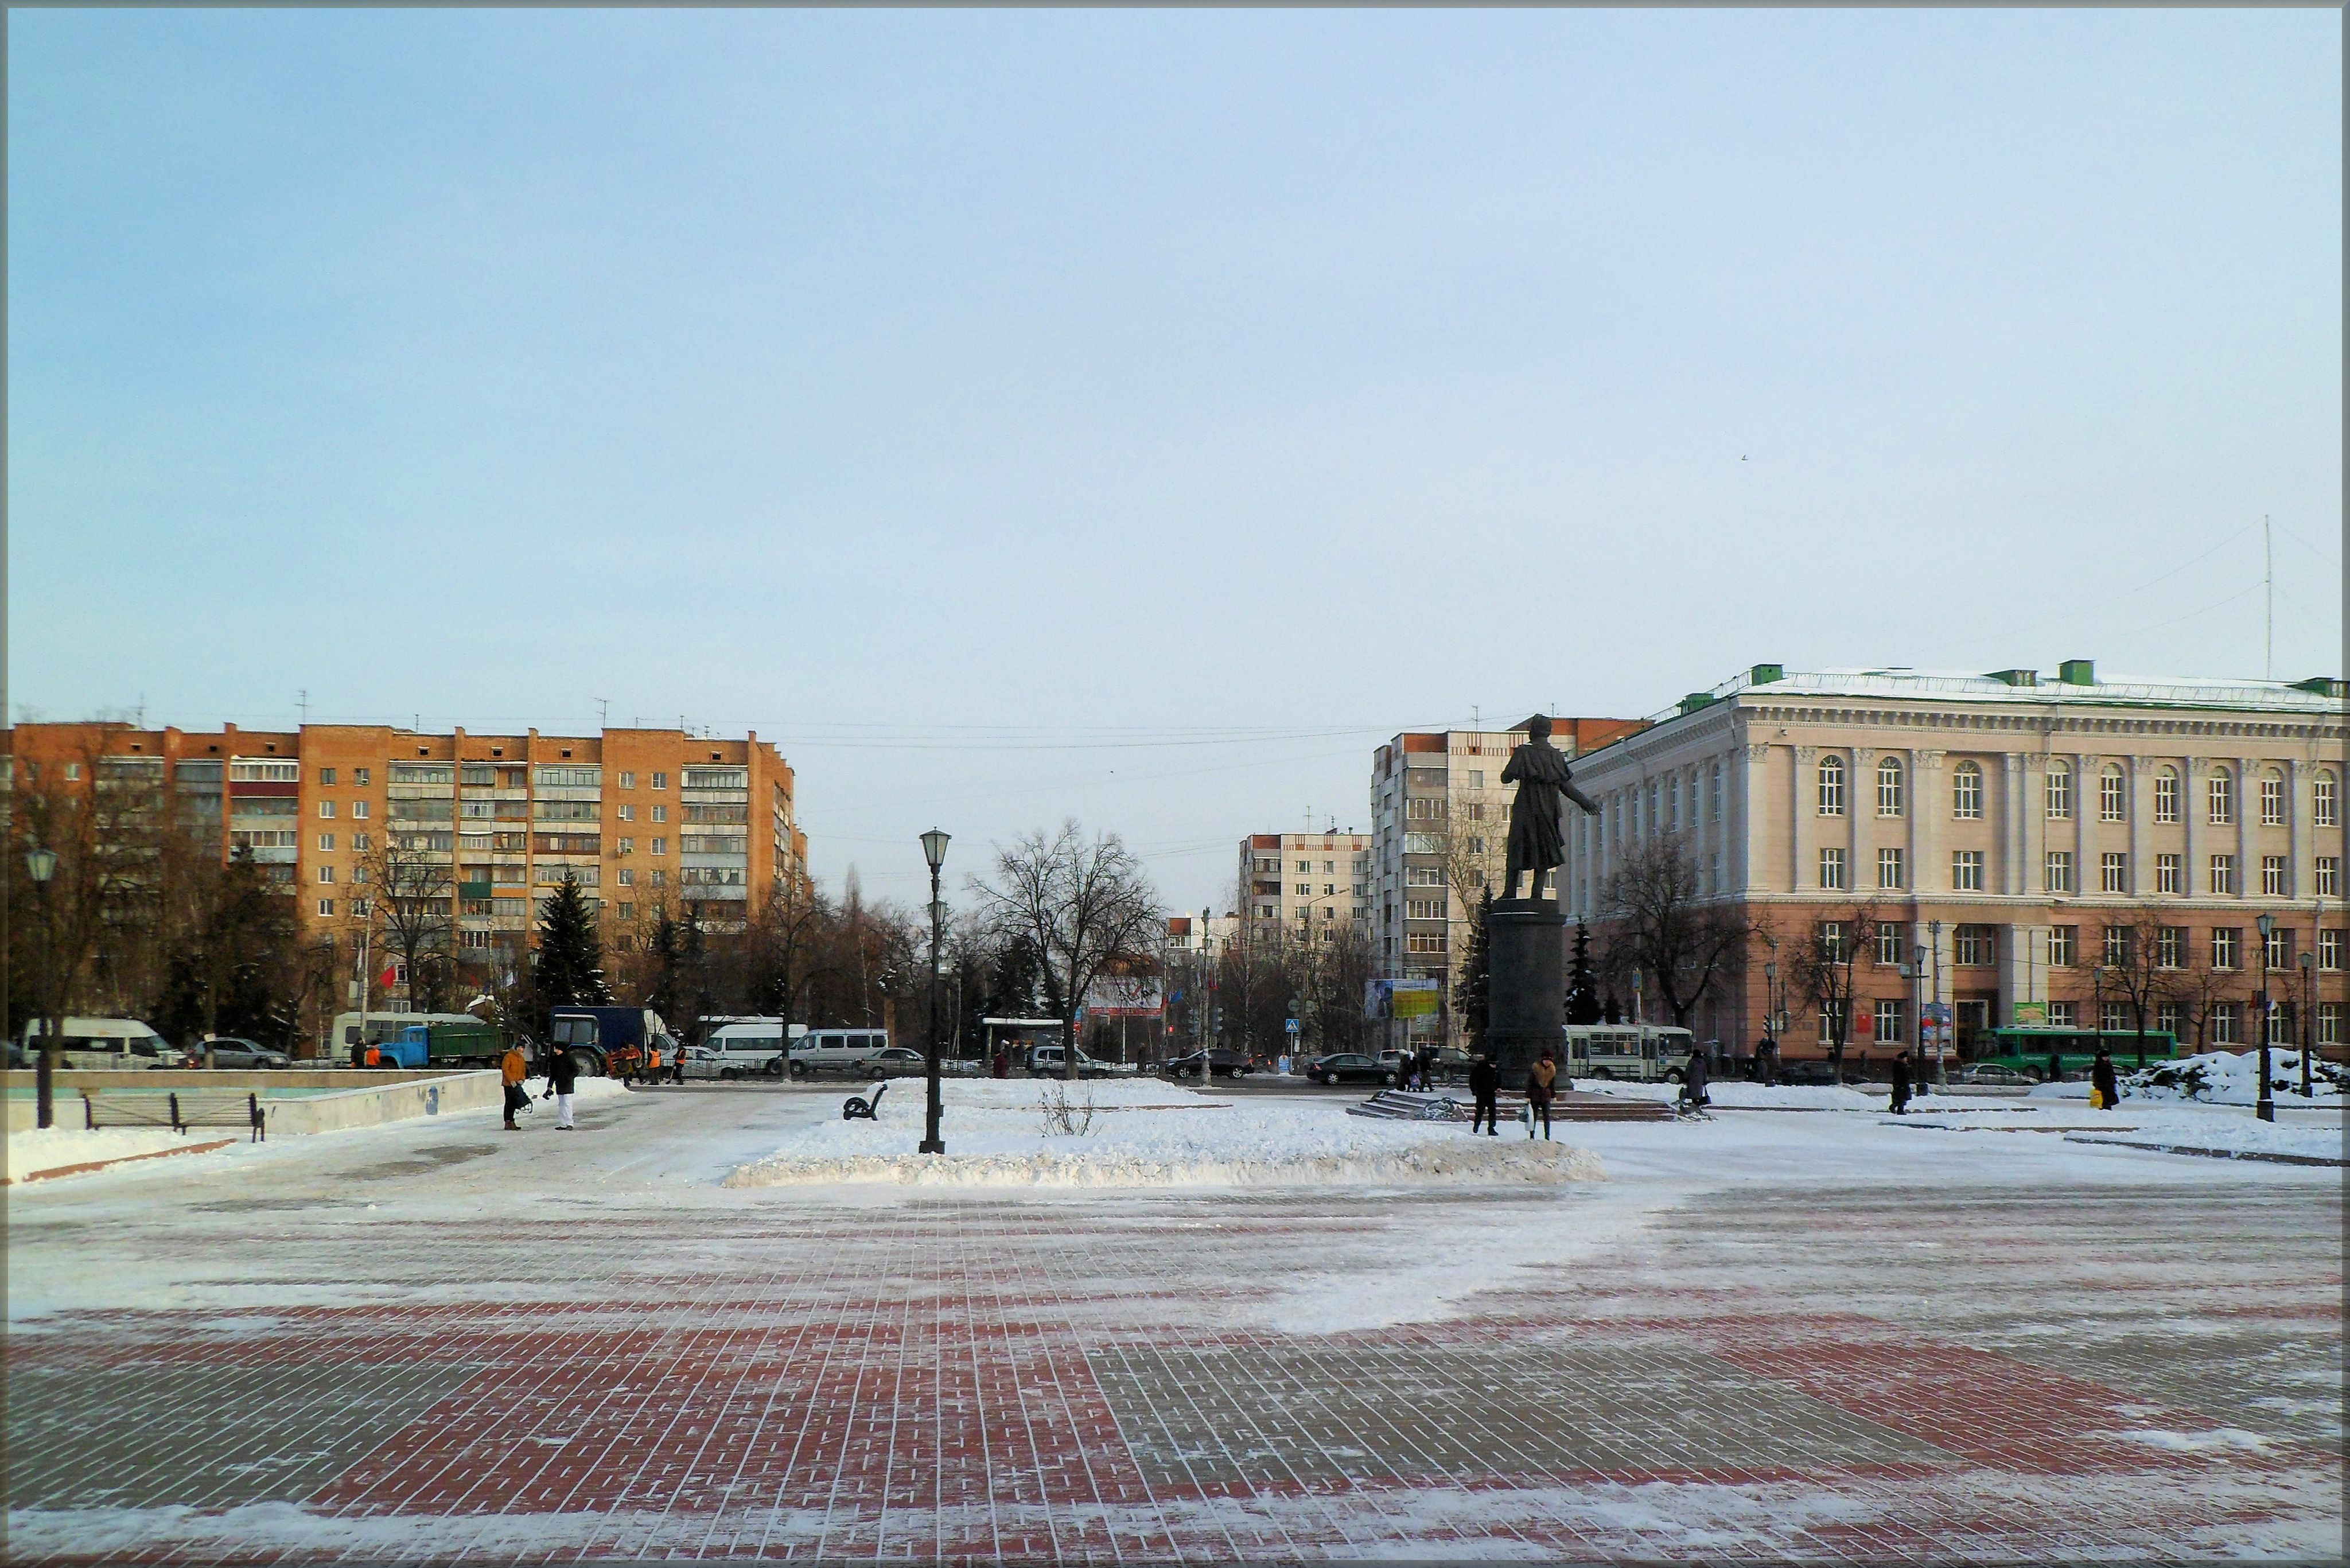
left=7, top=1091, right=2343, bottom=1563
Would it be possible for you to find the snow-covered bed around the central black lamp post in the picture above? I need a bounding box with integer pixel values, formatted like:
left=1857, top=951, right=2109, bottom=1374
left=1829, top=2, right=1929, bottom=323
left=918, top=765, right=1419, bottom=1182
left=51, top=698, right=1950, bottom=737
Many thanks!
left=726, top=1079, right=1602, bottom=1187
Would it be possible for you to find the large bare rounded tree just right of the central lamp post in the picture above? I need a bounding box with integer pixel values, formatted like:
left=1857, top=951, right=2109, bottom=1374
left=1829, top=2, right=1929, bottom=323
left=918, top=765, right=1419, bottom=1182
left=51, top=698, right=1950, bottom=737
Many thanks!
left=971, top=818, right=1166, bottom=1079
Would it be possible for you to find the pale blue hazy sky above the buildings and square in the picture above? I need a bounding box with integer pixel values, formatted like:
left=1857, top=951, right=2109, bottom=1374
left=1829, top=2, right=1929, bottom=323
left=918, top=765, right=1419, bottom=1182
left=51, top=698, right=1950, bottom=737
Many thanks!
left=7, top=9, right=2343, bottom=908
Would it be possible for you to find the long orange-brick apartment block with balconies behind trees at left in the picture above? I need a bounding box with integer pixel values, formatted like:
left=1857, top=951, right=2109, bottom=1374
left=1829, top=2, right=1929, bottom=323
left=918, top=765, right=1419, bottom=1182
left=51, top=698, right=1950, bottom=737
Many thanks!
left=0, top=724, right=808, bottom=950
